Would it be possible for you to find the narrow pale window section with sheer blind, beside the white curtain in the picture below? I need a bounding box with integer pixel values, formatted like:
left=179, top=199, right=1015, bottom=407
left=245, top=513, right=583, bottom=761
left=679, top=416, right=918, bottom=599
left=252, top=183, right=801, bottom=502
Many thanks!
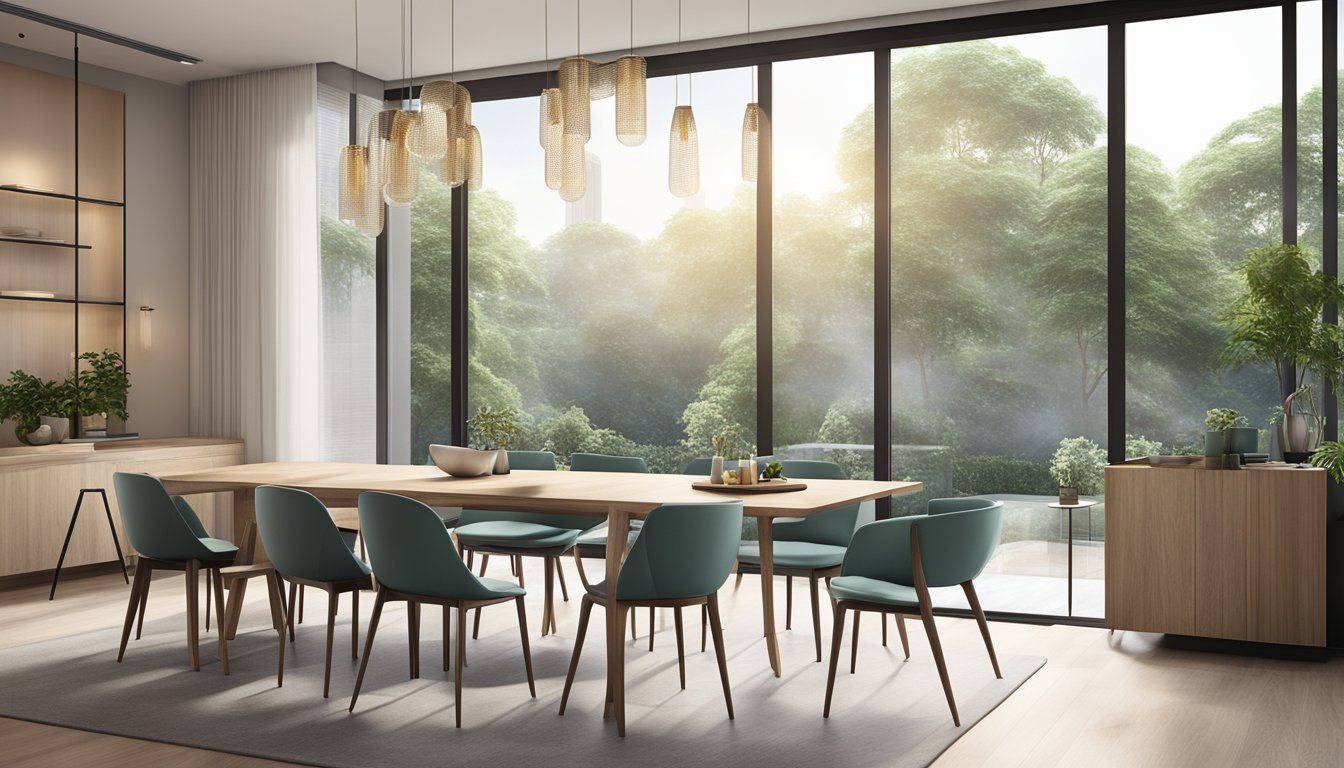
left=317, top=83, right=379, bottom=463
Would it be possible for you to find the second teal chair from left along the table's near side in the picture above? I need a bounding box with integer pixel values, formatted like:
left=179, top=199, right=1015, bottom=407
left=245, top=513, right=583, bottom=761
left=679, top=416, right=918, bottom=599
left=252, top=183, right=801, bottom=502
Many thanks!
left=257, top=486, right=374, bottom=698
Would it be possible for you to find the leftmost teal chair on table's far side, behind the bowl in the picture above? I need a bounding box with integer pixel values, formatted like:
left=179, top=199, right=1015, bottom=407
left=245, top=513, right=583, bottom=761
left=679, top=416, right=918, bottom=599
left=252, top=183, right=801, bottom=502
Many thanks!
left=454, top=451, right=588, bottom=638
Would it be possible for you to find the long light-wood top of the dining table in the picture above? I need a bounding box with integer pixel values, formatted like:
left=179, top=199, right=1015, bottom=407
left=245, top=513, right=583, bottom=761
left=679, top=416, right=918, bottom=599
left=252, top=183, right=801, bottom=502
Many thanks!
left=152, top=461, right=923, bottom=518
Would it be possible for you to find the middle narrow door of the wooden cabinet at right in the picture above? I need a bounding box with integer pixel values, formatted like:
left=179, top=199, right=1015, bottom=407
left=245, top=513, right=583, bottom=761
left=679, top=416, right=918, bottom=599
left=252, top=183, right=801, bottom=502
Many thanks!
left=1195, top=471, right=1251, bottom=640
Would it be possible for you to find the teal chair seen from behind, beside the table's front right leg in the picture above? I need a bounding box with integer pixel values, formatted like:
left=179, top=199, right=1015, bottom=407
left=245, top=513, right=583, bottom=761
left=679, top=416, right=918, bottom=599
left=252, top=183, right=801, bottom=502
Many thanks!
left=560, top=502, right=742, bottom=736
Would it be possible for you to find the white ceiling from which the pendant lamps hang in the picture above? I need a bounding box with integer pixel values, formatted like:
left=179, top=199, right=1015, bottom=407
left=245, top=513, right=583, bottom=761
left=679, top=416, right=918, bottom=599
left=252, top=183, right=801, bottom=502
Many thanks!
left=0, top=0, right=1078, bottom=83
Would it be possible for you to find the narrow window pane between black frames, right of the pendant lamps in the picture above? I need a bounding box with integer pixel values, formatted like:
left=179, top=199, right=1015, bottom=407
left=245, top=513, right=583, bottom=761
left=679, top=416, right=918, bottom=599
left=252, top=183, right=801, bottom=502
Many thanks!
left=771, top=54, right=874, bottom=480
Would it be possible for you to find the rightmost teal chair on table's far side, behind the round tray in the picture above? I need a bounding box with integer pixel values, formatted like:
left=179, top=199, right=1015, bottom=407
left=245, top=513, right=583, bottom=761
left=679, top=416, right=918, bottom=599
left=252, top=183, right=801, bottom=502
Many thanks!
left=736, top=459, right=870, bottom=662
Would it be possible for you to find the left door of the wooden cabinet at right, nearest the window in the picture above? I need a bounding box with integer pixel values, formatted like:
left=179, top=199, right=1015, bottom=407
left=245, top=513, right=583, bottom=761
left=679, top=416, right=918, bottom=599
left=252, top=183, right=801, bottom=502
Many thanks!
left=1106, top=467, right=1199, bottom=635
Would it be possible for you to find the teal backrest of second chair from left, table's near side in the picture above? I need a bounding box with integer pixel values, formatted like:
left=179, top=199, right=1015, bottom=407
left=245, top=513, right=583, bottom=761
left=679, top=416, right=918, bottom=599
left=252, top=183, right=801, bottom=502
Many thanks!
left=257, top=486, right=368, bottom=581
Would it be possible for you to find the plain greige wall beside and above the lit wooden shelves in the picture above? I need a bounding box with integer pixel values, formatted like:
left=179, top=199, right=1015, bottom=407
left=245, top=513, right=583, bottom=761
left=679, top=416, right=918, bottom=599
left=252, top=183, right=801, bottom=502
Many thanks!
left=0, top=44, right=188, bottom=437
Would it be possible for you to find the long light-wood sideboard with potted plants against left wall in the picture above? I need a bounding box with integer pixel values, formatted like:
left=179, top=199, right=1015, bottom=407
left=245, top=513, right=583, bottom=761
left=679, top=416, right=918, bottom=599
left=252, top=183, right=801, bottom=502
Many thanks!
left=0, top=437, right=243, bottom=577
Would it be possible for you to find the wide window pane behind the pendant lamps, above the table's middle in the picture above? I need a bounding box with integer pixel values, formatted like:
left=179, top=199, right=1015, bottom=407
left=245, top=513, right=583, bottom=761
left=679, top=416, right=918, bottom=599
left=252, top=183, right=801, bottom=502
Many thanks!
left=462, top=70, right=755, bottom=472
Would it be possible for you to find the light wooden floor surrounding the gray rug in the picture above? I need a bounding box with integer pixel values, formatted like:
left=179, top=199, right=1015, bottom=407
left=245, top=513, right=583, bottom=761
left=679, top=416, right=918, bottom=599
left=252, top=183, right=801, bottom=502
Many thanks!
left=0, top=564, right=1344, bottom=768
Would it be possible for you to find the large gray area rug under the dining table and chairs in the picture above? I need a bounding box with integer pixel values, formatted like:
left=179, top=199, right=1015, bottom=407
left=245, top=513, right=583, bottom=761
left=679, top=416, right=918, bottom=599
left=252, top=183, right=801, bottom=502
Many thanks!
left=0, top=594, right=1046, bottom=768
